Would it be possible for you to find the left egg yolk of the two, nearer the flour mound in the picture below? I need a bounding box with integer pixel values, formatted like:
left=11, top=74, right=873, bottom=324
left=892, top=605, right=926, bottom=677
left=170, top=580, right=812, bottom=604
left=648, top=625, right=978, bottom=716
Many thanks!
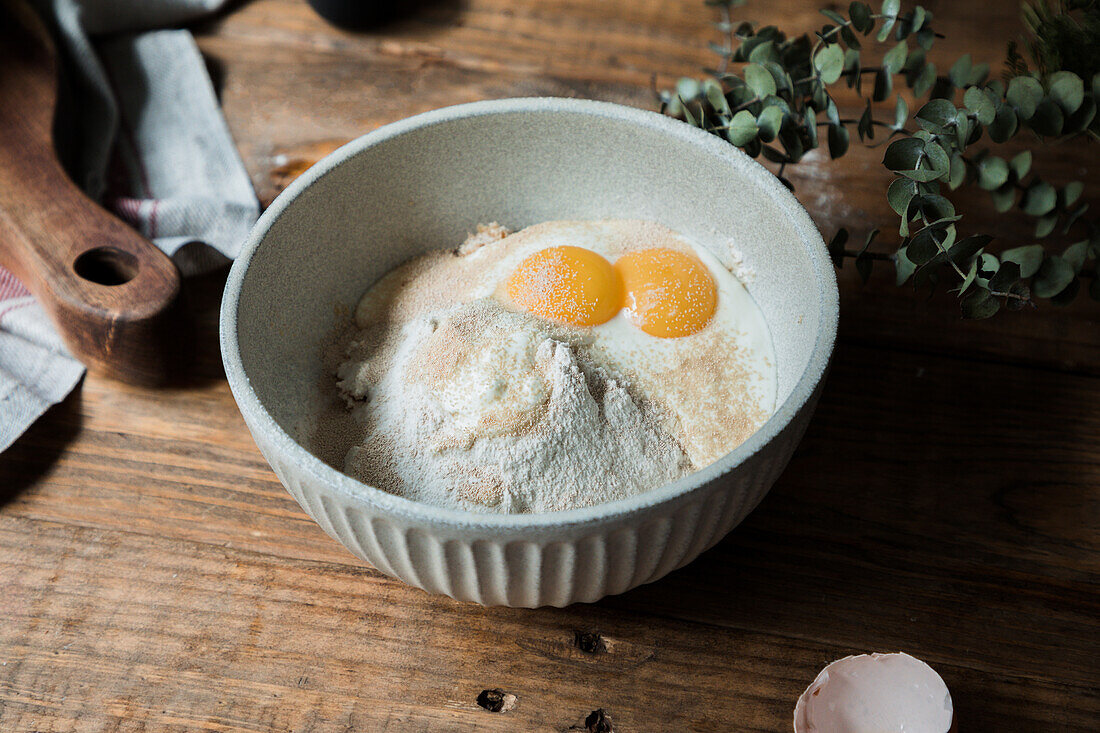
left=507, top=247, right=623, bottom=326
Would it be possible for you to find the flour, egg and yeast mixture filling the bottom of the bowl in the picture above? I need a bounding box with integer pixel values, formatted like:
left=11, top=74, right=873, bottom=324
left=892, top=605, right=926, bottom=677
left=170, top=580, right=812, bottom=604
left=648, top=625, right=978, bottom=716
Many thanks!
left=323, top=220, right=776, bottom=513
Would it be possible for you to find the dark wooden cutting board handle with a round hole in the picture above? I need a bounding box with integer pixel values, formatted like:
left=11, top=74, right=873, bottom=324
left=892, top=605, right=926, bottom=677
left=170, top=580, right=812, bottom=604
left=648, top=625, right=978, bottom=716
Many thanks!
left=0, top=0, right=179, bottom=384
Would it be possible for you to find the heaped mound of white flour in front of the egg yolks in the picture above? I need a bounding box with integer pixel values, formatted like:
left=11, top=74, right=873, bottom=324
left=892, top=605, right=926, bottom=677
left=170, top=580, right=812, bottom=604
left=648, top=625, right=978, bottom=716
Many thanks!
left=339, top=299, right=693, bottom=513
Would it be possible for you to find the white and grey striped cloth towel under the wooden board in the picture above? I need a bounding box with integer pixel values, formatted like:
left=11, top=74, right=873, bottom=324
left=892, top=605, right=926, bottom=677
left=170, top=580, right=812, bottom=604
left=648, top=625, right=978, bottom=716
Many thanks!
left=0, top=0, right=260, bottom=451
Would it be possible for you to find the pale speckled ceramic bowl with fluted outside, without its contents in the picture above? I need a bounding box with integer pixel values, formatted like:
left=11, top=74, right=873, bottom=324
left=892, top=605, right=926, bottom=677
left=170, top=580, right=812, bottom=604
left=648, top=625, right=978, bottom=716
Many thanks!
left=221, top=99, right=837, bottom=606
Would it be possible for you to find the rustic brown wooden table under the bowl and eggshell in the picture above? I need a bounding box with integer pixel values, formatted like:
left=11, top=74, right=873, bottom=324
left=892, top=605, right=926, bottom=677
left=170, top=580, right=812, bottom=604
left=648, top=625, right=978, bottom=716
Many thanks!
left=0, top=0, right=1100, bottom=733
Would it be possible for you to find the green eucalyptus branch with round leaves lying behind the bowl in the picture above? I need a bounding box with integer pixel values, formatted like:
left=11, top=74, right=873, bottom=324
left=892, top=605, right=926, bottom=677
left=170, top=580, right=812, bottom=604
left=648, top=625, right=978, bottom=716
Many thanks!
left=660, top=0, right=1100, bottom=318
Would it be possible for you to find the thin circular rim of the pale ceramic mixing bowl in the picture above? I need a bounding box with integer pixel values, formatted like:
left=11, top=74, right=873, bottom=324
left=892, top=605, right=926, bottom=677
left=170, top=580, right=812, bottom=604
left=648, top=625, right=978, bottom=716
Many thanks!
left=219, top=97, right=839, bottom=532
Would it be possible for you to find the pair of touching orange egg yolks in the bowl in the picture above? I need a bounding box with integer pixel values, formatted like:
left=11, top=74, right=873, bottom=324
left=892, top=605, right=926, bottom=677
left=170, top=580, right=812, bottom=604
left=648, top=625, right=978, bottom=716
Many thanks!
left=507, top=247, right=718, bottom=338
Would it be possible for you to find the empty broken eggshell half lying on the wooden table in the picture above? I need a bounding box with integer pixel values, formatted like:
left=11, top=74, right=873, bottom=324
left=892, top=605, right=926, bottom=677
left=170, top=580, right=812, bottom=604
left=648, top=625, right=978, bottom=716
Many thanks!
left=794, top=653, right=955, bottom=733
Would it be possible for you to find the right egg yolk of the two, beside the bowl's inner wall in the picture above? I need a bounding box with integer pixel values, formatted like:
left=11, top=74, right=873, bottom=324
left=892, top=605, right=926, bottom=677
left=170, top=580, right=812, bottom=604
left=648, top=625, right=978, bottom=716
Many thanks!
left=615, top=248, right=718, bottom=339
